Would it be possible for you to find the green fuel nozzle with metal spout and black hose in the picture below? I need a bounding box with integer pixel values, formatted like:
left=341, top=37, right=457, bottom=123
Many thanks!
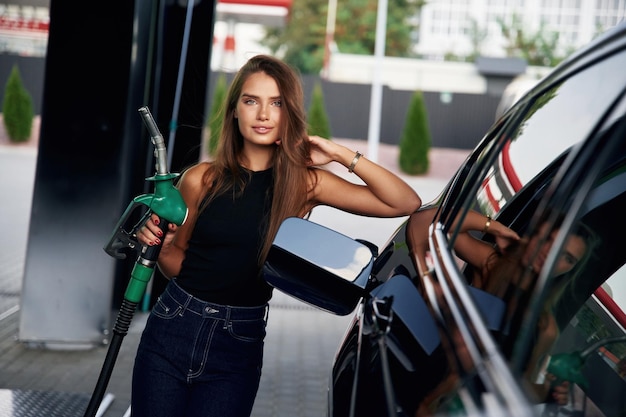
left=84, top=107, right=188, bottom=417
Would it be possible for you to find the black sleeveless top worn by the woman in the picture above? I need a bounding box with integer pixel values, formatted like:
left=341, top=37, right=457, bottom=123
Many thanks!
left=176, top=168, right=273, bottom=306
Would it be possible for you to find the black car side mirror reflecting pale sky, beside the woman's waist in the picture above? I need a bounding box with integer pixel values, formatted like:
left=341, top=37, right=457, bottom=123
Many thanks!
left=263, top=217, right=374, bottom=316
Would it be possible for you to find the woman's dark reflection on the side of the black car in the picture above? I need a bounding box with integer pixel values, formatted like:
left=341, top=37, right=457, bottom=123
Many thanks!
left=407, top=209, right=594, bottom=410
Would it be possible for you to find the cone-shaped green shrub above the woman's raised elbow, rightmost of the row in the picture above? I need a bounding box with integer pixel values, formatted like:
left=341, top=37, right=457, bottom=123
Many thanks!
left=398, top=91, right=431, bottom=175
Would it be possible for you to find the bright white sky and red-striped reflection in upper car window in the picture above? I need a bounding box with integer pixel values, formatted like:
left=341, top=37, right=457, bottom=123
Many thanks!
left=466, top=49, right=626, bottom=221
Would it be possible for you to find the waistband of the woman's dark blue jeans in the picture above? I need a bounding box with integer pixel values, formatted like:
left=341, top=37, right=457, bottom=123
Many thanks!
left=164, top=279, right=268, bottom=320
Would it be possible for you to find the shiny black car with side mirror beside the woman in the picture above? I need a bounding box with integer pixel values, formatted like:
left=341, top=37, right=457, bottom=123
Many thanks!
left=264, top=24, right=626, bottom=417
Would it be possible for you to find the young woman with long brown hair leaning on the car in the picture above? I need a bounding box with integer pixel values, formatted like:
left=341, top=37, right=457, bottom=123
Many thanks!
left=132, top=55, right=421, bottom=417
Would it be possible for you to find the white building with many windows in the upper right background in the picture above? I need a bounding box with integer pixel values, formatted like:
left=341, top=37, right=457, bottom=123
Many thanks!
left=415, top=0, right=626, bottom=59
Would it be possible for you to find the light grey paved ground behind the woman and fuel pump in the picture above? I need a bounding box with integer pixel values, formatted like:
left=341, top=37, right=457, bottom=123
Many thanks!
left=0, top=128, right=467, bottom=417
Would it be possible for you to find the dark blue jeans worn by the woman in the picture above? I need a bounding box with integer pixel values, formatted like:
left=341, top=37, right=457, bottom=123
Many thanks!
left=131, top=280, right=268, bottom=417
